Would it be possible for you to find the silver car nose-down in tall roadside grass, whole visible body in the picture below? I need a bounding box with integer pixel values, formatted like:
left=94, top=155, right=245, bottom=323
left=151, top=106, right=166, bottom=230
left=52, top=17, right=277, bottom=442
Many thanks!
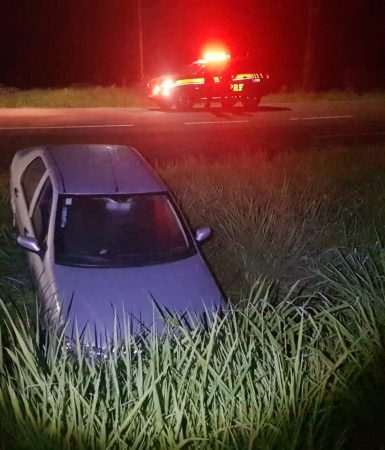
left=10, top=145, right=223, bottom=342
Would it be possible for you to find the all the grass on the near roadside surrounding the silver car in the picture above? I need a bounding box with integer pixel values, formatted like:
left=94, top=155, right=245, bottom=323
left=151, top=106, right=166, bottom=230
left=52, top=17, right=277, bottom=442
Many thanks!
left=0, top=145, right=385, bottom=449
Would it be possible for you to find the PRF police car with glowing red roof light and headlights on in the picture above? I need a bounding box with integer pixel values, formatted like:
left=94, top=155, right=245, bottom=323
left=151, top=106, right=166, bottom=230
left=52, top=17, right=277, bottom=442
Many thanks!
left=146, top=52, right=270, bottom=111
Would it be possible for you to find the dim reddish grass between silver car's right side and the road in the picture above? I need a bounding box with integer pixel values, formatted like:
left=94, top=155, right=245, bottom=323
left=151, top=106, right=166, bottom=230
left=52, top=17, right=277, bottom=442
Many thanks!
left=158, top=146, right=385, bottom=296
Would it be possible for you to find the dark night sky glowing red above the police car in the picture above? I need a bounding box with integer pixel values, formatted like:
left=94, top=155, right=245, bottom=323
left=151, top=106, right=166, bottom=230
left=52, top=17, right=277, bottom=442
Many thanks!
left=0, top=0, right=385, bottom=89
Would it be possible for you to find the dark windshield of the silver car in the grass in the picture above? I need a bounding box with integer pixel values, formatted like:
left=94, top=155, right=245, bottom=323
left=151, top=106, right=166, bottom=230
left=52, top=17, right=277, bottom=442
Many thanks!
left=55, top=194, right=195, bottom=267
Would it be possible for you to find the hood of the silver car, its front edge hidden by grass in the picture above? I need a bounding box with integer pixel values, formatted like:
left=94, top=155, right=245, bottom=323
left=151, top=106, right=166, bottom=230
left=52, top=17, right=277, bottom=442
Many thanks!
left=54, top=254, right=223, bottom=340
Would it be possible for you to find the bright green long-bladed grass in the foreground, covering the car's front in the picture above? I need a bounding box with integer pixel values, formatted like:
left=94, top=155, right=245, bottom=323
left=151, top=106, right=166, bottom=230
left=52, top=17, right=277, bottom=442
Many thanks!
left=0, top=268, right=385, bottom=449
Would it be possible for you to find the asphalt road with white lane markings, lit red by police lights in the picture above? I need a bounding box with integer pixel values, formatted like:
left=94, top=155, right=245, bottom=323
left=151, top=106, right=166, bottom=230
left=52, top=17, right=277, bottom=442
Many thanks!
left=0, top=100, right=385, bottom=169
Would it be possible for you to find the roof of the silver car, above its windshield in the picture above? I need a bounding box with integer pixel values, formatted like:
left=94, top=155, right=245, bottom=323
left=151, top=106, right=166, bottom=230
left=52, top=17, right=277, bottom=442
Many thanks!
left=17, top=144, right=167, bottom=194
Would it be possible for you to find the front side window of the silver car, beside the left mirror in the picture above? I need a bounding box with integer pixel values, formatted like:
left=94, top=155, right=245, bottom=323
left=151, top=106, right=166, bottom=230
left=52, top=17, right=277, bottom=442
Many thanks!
left=31, top=177, right=52, bottom=244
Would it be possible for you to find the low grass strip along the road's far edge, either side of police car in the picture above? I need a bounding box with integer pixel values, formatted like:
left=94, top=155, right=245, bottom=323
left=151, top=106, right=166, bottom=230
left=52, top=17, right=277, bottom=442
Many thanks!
left=0, top=86, right=385, bottom=108
